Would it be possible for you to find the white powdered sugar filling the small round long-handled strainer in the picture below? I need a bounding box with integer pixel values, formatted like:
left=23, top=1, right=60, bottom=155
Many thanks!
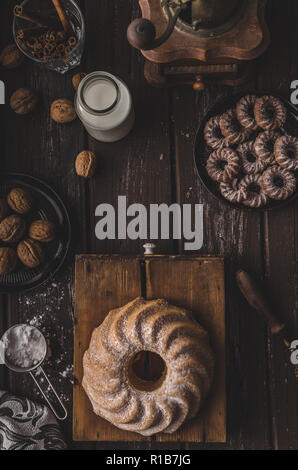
left=3, top=325, right=46, bottom=369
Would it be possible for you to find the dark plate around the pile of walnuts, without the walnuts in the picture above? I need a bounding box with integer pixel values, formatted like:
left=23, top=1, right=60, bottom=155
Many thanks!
left=0, top=173, right=71, bottom=293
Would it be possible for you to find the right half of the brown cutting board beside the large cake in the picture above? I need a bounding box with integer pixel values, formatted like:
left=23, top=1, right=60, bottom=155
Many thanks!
left=145, top=257, right=226, bottom=442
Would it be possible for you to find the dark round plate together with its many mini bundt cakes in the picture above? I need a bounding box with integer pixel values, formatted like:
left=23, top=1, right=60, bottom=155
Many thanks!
left=194, top=93, right=298, bottom=211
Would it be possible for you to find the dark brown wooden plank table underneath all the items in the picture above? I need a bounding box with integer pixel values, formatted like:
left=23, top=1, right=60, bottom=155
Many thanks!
left=0, top=0, right=298, bottom=449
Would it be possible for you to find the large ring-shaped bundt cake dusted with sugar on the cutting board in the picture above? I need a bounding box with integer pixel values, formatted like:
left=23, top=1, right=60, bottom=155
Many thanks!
left=82, top=297, right=214, bottom=436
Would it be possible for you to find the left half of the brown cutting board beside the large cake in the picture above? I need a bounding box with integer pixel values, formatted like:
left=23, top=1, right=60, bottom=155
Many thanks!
left=73, top=256, right=146, bottom=441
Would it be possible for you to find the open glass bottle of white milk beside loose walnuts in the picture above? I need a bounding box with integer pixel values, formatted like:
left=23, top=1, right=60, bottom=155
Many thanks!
left=75, top=72, right=135, bottom=142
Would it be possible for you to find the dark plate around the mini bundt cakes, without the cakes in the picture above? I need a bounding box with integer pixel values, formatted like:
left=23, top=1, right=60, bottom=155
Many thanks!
left=194, top=92, right=298, bottom=211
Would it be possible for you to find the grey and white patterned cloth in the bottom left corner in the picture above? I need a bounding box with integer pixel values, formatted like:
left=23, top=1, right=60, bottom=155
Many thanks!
left=0, top=391, right=66, bottom=450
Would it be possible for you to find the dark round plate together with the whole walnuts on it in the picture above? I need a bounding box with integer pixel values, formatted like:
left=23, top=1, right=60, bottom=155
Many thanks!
left=0, top=173, right=70, bottom=292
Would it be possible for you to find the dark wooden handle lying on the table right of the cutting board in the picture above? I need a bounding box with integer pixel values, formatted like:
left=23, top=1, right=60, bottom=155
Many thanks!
left=236, top=269, right=285, bottom=335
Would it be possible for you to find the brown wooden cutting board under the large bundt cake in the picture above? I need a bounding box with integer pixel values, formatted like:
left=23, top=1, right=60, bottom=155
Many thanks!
left=73, top=255, right=226, bottom=442
